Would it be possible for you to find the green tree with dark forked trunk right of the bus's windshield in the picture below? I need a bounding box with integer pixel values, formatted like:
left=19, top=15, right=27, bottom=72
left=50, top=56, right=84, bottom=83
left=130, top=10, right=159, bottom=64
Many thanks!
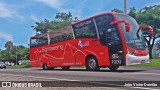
left=136, top=5, right=160, bottom=58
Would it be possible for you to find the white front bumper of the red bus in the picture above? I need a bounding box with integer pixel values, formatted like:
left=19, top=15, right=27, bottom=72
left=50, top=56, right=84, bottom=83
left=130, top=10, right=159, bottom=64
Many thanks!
left=126, top=54, right=150, bottom=65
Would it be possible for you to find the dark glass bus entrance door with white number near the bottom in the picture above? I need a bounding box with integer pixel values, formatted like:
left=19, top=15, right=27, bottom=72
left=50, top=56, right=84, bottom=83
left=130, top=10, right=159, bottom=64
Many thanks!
left=107, top=27, right=124, bottom=66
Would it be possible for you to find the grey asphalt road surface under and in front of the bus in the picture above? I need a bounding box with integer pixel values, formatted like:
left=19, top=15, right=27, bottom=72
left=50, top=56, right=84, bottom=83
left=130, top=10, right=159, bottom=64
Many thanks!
left=0, top=67, right=160, bottom=90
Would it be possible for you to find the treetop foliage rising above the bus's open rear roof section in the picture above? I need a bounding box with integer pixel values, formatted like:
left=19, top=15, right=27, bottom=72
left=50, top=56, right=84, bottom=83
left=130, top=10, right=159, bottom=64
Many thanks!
left=31, top=12, right=78, bottom=34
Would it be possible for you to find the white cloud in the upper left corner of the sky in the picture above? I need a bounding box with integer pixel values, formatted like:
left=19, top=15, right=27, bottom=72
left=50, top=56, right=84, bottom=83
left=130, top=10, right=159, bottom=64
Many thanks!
left=0, top=2, right=24, bottom=19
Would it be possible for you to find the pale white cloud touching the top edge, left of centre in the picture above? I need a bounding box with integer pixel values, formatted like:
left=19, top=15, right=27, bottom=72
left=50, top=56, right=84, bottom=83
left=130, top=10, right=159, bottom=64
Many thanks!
left=35, top=0, right=62, bottom=10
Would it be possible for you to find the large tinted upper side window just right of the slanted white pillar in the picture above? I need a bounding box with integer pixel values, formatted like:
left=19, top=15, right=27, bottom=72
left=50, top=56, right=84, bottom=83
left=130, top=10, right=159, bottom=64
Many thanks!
left=72, top=19, right=97, bottom=38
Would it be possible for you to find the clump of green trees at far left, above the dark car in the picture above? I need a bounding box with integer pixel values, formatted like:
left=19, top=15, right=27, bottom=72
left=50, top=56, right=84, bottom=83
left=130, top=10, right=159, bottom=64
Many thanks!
left=0, top=41, right=29, bottom=62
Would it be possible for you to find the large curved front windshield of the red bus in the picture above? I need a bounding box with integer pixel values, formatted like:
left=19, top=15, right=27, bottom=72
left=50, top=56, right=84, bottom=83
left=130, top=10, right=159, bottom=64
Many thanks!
left=117, top=14, right=147, bottom=50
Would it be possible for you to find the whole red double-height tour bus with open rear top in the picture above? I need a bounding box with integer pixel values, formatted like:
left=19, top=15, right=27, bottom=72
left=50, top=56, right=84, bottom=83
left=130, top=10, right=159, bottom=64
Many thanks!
left=30, top=12, right=153, bottom=70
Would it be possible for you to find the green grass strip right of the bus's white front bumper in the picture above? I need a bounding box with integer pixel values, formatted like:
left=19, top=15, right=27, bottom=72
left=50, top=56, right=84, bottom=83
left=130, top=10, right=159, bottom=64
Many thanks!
left=126, top=59, right=160, bottom=68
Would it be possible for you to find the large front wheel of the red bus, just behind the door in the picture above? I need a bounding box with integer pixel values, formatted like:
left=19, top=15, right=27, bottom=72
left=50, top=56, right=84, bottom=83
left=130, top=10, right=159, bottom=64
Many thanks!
left=86, top=56, right=100, bottom=71
